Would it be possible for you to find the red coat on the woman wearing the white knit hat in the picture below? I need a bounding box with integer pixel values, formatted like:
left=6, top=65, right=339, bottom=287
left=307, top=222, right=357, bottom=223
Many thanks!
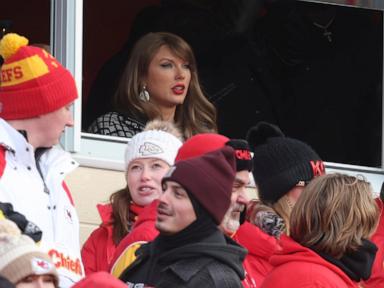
left=81, top=204, right=143, bottom=275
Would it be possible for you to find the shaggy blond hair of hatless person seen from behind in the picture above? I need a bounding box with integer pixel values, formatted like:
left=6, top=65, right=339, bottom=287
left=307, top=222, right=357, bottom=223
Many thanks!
left=290, top=173, right=379, bottom=258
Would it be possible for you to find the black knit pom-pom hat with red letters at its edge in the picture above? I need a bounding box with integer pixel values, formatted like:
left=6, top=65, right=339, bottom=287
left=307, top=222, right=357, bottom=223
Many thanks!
left=247, top=122, right=325, bottom=204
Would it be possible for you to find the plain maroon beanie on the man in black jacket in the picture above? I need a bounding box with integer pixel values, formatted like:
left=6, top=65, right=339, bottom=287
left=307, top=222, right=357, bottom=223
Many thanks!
left=162, top=146, right=236, bottom=225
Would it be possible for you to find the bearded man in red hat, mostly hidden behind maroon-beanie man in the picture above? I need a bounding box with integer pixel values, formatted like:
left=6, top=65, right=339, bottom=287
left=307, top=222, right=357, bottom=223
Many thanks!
left=111, top=133, right=266, bottom=288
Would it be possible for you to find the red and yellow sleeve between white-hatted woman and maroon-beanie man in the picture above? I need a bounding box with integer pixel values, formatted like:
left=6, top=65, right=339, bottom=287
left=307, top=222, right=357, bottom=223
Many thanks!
left=108, top=200, right=159, bottom=277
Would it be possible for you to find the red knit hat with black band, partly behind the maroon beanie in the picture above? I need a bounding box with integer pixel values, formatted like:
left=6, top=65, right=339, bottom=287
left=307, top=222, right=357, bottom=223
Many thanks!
left=175, top=133, right=252, bottom=171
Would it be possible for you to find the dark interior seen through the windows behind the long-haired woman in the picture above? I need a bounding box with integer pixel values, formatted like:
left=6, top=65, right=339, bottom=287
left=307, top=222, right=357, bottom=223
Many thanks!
left=0, top=0, right=383, bottom=167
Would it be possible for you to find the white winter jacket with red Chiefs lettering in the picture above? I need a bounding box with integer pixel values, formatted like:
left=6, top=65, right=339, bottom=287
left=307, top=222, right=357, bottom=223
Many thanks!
left=0, top=119, right=84, bottom=287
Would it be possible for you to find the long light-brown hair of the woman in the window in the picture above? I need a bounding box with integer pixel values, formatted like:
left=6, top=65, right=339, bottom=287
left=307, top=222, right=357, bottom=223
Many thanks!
left=114, top=32, right=217, bottom=138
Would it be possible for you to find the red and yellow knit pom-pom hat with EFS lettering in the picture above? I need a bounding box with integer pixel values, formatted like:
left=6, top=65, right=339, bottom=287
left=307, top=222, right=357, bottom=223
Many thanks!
left=0, top=33, right=77, bottom=120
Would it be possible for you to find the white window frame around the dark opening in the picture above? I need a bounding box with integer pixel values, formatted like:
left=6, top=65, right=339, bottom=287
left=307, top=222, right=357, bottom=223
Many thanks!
left=55, top=0, right=384, bottom=192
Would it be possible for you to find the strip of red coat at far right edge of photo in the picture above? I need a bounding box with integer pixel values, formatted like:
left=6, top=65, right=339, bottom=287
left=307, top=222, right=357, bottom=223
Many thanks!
left=362, top=198, right=384, bottom=288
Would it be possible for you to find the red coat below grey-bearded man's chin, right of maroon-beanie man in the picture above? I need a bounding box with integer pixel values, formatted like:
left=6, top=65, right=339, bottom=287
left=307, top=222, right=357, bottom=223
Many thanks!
left=233, top=222, right=279, bottom=288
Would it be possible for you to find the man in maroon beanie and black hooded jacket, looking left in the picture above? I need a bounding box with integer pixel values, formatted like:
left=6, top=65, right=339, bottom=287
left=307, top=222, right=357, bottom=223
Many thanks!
left=120, top=147, right=246, bottom=288
